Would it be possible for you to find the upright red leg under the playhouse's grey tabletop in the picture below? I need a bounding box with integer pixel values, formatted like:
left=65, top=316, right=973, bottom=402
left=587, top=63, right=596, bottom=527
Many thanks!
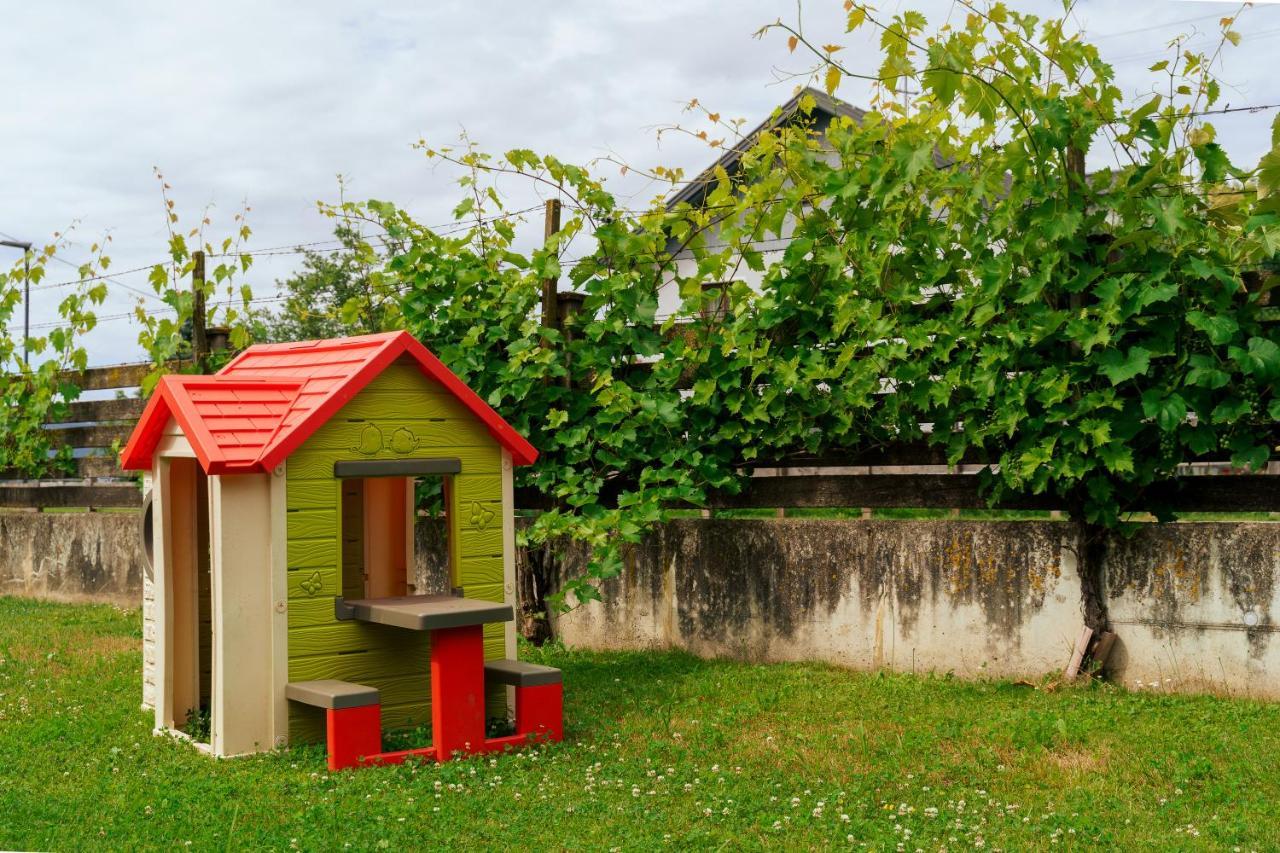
left=431, top=625, right=485, bottom=761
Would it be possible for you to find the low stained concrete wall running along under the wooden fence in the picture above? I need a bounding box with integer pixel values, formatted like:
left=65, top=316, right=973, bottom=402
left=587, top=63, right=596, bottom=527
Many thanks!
left=10, top=512, right=1280, bottom=698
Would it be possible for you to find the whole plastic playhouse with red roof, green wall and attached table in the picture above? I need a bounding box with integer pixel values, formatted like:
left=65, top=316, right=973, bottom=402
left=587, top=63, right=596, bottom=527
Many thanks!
left=123, top=332, right=562, bottom=770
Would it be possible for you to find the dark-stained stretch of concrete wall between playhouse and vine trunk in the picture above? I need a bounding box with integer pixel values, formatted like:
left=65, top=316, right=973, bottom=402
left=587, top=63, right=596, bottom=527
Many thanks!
left=559, top=519, right=1079, bottom=670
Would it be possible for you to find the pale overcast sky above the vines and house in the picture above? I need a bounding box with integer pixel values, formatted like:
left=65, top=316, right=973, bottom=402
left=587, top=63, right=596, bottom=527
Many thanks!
left=0, top=0, right=1280, bottom=364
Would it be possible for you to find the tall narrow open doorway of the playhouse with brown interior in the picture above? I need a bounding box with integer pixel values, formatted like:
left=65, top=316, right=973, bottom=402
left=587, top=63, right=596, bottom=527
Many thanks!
left=164, top=459, right=214, bottom=743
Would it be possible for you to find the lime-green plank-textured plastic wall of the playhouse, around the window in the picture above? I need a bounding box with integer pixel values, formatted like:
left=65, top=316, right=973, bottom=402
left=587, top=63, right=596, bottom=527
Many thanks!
left=285, top=362, right=506, bottom=743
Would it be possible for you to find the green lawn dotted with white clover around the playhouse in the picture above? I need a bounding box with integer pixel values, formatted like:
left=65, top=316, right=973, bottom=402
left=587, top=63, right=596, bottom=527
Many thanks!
left=0, top=598, right=1280, bottom=850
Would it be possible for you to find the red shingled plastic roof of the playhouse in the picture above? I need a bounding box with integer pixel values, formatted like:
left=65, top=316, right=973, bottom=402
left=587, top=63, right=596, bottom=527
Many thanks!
left=120, top=332, right=538, bottom=474
